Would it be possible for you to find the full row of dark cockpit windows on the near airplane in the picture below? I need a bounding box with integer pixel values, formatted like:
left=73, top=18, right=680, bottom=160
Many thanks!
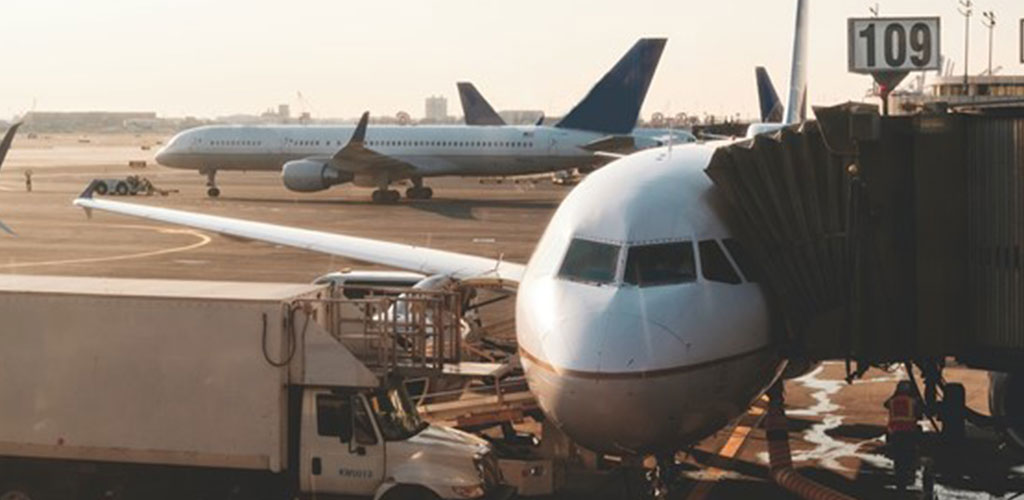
left=558, top=238, right=760, bottom=287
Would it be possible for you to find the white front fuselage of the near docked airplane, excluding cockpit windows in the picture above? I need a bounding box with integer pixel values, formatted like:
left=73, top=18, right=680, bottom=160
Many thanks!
left=516, top=144, right=782, bottom=454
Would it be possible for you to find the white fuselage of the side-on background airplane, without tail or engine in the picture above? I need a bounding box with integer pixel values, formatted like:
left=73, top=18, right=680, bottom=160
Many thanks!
left=157, top=125, right=604, bottom=180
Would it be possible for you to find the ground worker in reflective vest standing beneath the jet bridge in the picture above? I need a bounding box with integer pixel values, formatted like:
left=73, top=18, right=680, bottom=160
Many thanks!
left=885, top=380, right=923, bottom=489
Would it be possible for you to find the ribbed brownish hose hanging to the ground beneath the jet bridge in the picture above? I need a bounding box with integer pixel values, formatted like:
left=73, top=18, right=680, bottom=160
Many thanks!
left=764, top=381, right=854, bottom=500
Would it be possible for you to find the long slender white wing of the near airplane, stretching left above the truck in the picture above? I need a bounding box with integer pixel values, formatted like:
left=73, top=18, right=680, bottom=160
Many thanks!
left=75, top=193, right=525, bottom=282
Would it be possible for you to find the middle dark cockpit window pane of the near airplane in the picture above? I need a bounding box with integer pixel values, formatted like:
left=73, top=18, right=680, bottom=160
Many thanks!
left=625, top=242, right=697, bottom=287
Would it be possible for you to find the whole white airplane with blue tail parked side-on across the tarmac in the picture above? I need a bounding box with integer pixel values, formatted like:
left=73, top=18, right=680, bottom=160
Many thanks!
left=151, top=38, right=666, bottom=202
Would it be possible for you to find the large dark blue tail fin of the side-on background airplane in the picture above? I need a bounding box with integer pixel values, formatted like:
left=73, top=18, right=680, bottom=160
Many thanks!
left=555, top=38, right=667, bottom=134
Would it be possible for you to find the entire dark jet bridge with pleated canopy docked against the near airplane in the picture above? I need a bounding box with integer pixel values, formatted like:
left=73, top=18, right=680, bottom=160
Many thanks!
left=707, top=103, right=1024, bottom=369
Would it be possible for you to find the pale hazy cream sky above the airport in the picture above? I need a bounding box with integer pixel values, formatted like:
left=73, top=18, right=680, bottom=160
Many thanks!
left=0, top=0, right=1024, bottom=118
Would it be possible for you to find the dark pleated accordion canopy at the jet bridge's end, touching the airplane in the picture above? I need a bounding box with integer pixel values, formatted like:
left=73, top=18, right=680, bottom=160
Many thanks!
left=707, top=122, right=851, bottom=362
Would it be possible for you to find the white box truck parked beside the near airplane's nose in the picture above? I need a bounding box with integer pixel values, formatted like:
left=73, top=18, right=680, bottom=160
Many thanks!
left=0, top=275, right=509, bottom=500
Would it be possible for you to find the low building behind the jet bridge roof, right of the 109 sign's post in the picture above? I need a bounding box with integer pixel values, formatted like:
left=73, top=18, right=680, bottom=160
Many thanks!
left=889, top=75, right=1024, bottom=115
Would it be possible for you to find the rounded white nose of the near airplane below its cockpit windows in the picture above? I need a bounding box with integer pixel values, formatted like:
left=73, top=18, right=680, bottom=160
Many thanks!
left=516, top=280, right=779, bottom=453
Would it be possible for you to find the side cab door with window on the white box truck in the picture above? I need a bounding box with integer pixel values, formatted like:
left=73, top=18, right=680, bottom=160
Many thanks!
left=299, top=390, right=384, bottom=495
